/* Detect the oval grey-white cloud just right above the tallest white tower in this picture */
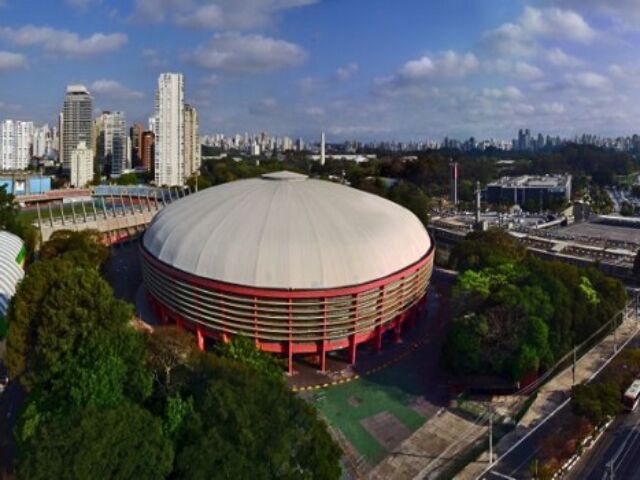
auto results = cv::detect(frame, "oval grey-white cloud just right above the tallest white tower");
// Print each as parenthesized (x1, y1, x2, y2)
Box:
(183, 33, 307, 73)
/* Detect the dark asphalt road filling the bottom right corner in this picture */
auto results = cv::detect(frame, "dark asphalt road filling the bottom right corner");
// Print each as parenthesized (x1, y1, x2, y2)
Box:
(567, 409, 640, 480)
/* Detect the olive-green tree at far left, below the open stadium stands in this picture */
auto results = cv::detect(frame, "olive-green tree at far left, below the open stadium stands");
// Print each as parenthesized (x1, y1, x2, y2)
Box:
(6, 259, 133, 387)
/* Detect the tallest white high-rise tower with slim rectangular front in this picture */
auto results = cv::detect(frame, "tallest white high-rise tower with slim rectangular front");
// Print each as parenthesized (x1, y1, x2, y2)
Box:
(154, 73, 185, 186)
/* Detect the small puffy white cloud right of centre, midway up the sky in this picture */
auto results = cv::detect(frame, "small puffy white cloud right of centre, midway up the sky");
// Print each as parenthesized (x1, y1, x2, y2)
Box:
(398, 50, 480, 81)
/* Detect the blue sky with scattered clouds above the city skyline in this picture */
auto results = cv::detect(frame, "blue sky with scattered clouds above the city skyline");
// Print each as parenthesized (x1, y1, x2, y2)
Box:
(0, 0, 640, 140)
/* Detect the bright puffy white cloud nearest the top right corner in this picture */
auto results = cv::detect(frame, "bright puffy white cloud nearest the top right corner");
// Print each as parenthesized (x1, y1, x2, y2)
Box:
(485, 7, 596, 55)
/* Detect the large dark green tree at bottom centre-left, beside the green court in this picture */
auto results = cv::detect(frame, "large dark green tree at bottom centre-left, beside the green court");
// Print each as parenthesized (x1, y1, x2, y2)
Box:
(174, 355, 340, 480)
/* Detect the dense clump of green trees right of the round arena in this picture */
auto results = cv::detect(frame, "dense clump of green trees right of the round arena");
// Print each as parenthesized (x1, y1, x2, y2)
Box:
(444, 230, 626, 380)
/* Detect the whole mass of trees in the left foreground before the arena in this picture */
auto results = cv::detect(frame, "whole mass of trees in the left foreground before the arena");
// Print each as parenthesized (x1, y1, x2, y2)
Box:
(6, 232, 341, 480)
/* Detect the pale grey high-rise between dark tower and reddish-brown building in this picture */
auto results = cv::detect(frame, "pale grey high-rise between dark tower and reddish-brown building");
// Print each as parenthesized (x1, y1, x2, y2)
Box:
(96, 112, 127, 175)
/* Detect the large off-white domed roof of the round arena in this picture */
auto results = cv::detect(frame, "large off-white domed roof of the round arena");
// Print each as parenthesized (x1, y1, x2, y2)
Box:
(143, 172, 431, 289)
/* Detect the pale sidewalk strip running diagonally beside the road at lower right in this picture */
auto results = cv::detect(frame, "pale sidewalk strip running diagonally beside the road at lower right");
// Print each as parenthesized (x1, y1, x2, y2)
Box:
(456, 317, 640, 480)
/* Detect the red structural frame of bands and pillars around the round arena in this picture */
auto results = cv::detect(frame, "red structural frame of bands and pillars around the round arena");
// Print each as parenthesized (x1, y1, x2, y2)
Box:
(140, 241, 435, 373)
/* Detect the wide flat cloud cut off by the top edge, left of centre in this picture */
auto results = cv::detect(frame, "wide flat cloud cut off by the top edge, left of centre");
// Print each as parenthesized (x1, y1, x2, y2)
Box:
(132, 0, 318, 30)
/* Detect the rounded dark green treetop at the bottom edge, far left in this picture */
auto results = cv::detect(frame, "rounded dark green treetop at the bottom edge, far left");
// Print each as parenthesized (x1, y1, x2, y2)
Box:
(18, 404, 173, 480)
